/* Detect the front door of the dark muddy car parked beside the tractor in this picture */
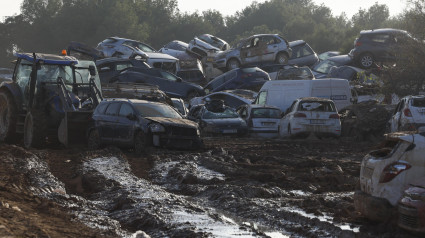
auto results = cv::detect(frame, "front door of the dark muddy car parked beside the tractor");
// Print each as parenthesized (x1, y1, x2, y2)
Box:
(114, 102, 138, 145)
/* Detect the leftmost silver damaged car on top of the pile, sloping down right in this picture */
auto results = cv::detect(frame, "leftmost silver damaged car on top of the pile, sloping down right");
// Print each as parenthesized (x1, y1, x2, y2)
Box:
(96, 37, 180, 73)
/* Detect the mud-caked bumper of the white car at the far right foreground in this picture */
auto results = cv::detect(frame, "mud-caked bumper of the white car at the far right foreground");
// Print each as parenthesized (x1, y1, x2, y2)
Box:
(354, 190, 397, 221)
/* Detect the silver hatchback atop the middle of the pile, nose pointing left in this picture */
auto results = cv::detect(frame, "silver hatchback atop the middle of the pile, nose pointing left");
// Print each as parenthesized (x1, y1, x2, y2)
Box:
(213, 34, 292, 70)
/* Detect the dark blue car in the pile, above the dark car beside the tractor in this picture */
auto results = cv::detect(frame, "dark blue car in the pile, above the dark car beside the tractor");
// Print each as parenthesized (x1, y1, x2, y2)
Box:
(109, 67, 205, 99)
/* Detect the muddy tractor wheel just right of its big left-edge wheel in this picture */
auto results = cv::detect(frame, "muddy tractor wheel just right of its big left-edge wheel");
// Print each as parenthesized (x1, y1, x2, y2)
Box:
(24, 110, 47, 148)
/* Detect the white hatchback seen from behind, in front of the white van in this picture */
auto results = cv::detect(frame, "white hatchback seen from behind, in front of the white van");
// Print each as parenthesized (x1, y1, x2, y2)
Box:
(279, 97, 341, 138)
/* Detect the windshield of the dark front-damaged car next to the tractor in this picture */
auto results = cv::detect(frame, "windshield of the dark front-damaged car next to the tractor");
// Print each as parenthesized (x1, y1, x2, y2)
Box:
(134, 103, 182, 118)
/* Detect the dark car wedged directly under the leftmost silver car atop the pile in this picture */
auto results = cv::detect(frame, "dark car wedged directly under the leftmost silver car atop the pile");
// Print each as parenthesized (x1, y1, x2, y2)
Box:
(96, 57, 150, 84)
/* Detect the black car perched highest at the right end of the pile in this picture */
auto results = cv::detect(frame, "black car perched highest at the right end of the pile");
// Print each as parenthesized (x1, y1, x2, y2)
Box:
(349, 29, 415, 68)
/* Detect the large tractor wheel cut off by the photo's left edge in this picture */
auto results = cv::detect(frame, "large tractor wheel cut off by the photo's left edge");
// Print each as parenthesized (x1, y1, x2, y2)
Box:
(0, 90, 18, 143)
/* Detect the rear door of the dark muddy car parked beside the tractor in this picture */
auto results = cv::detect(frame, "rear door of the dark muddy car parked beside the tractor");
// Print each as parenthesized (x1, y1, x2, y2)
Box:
(97, 102, 120, 144)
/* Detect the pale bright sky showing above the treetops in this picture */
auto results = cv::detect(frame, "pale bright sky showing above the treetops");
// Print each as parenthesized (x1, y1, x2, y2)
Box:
(0, 0, 407, 21)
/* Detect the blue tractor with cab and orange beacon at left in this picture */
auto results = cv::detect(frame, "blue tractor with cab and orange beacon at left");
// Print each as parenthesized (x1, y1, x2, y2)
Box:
(0, 53, 103, 148)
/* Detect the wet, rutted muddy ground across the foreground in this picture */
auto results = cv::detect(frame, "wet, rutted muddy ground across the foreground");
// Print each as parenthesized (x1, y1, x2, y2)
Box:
(0, 138, 420, 237)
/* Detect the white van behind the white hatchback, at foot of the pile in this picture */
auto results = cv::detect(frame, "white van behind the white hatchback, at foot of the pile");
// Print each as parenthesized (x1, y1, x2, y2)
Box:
(254, 79, 354, 112)
